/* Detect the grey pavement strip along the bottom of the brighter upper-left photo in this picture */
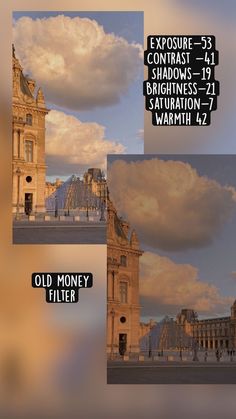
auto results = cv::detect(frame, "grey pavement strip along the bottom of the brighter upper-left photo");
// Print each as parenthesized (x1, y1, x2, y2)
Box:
(13, 221, 106, 244)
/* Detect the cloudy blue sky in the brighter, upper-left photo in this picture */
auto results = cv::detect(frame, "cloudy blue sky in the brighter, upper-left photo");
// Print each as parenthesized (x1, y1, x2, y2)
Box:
(13, 12, 144, 180)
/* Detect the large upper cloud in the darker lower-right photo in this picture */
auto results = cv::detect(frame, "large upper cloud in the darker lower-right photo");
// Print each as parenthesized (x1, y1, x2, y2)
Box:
(108, 158, 235, 250)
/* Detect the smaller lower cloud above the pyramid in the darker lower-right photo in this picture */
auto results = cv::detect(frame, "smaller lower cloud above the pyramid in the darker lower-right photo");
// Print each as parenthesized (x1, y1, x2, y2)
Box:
(140, 252, 234, 316)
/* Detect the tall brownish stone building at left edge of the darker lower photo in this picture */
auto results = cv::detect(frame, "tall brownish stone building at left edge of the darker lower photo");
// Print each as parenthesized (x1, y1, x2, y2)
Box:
(107, 199, 143, 358)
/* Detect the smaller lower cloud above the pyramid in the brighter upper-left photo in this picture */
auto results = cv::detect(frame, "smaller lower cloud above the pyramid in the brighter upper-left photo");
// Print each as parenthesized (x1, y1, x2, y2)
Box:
(46, 110, 125, 175)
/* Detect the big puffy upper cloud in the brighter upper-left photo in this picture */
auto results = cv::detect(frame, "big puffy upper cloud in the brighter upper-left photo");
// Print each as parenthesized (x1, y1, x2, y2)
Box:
(13, 15, 142, 110)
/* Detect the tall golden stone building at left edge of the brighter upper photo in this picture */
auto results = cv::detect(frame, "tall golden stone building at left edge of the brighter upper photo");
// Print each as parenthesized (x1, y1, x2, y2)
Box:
(12, 47, 49, 216)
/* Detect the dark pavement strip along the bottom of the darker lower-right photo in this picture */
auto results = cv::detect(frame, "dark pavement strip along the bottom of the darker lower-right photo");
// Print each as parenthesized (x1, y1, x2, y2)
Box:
(107, 362, 236, 384)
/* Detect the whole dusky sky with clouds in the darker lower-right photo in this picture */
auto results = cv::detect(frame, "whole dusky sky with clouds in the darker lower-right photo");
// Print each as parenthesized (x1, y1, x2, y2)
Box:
(108, 155, 236, 321)
